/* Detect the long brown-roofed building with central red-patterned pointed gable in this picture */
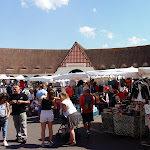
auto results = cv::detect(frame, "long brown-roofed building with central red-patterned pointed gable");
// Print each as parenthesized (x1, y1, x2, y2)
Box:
(0, 42, 150, 77)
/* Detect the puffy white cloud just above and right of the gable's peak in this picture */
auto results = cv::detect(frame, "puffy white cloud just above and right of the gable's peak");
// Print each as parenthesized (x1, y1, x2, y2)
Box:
(79, 26, 95, 38)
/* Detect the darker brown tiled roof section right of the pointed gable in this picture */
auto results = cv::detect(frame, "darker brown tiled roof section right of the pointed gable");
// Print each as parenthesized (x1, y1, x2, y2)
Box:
(84, 45, 150, 69)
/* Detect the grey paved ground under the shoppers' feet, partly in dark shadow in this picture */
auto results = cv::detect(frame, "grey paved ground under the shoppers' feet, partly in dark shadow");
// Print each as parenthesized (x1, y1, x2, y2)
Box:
(0, 111, 150, 150)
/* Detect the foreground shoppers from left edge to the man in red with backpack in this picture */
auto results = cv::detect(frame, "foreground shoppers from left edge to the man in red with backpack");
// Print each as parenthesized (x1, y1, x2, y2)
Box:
(0, 79, 95, 147)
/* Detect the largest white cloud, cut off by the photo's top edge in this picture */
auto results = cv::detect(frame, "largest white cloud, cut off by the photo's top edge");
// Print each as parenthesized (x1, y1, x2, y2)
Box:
(21, 0, 69, 11)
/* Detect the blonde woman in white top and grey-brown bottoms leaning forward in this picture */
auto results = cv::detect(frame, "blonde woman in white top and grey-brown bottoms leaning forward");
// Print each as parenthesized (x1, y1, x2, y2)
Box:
(60, 92, 78, 145)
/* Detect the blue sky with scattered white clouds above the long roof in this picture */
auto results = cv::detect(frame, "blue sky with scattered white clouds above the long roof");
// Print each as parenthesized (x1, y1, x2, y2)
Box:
(0, 0, 150, 49)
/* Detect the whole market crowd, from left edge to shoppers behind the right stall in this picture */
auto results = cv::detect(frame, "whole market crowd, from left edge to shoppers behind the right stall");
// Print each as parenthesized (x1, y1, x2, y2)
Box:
(0, 80, 143, 147)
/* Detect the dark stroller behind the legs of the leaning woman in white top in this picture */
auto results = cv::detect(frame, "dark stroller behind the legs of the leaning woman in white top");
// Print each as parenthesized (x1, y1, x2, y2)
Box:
(56, 115, 80, 142)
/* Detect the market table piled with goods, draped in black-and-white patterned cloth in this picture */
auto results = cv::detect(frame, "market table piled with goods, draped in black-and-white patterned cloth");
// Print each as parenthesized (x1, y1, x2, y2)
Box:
(101, 96, 149, 138)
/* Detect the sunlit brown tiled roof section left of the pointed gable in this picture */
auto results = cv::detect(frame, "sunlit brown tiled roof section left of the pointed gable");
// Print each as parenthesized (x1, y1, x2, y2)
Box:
(0, 48, 68, 74)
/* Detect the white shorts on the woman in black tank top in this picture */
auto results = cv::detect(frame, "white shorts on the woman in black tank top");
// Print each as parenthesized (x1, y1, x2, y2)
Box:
(40, 109, 54, 122)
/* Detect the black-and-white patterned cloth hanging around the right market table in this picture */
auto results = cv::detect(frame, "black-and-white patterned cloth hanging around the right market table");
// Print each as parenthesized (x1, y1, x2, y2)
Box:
(101, 110, 149, 138)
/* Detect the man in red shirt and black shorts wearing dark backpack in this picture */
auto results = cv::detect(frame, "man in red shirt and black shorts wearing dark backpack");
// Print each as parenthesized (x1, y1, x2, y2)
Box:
(79, 85, 95, 136)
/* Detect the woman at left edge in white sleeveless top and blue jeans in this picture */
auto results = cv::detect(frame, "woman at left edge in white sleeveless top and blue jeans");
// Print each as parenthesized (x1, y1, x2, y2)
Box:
(0, 93, 10, 146)
